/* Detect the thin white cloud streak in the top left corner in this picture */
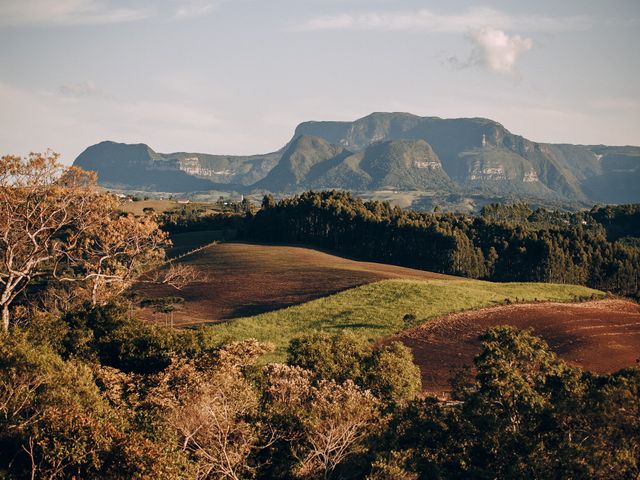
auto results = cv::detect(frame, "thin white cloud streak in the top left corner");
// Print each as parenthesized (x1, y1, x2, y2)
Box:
(0, 0, 151, 26)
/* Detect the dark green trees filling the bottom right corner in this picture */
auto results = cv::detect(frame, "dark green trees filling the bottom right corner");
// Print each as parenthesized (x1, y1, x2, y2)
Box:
(381, 327, 640, 479)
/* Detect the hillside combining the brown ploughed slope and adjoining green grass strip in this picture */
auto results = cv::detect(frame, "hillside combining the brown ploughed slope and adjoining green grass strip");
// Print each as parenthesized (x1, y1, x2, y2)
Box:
(136, 243, 601, 366)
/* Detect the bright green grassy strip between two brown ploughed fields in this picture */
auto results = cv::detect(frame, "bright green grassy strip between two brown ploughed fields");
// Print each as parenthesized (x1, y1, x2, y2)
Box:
(199, 280, 604, 362)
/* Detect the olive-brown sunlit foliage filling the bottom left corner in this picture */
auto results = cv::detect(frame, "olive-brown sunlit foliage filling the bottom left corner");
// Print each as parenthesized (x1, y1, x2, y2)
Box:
(0, 331, 190, 479)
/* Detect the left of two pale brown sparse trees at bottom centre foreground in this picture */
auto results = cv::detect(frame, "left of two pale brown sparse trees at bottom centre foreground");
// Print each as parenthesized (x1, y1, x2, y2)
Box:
(153, 340, 272, 480)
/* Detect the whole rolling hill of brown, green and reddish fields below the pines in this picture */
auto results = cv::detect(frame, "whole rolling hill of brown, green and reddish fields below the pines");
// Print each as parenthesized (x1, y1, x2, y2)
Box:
(130, 243, 640, 376)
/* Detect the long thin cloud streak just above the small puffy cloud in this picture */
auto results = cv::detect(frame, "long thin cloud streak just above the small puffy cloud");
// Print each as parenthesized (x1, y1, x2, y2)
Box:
(294, 7, 592, 33)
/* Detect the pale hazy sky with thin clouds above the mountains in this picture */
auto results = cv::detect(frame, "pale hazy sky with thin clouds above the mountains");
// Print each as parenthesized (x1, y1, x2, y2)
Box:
(0, 0, 640, 163)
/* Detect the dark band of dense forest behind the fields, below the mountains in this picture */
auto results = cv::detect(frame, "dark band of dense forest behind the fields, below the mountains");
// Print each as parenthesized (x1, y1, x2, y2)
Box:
(243, 191, 640, 298)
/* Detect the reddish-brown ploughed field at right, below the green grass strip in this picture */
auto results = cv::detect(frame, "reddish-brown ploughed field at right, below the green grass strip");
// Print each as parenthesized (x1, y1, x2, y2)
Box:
(396, 299, 640, 393)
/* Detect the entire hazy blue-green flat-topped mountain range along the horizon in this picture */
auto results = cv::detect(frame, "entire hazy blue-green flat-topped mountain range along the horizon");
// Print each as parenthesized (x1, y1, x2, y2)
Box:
(74, 113, 640, 204)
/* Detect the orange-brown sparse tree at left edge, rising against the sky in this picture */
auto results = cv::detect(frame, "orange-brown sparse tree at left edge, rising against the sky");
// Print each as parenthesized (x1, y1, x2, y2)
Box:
(0, 151, 97, 331)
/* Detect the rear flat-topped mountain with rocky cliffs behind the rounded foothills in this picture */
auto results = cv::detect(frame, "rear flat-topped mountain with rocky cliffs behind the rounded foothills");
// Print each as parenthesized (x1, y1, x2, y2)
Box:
(296, 113, 640, 202)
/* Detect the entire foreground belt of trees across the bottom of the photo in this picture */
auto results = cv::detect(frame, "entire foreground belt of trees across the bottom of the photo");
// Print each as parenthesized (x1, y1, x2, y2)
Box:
(0, 302, 640, 480)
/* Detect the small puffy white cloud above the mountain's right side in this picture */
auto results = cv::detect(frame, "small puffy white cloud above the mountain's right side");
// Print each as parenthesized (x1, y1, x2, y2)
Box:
(467, 27, 533, 75)
